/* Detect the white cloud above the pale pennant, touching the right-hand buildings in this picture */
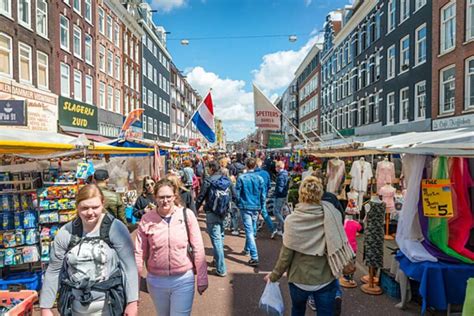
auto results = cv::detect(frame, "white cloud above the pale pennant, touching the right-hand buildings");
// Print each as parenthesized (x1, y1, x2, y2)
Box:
(252, 34, 322, 95)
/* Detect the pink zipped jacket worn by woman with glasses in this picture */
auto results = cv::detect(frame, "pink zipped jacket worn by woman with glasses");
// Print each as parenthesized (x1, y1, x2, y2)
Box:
(135, 208, 208, 286)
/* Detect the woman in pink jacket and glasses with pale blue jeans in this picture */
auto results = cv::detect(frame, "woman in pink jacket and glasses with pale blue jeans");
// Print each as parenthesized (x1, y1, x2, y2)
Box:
(135, 179, 208, 316)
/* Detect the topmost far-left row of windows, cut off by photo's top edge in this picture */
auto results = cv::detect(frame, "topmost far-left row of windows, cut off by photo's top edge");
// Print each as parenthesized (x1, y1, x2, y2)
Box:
(0, 0, 48, 38)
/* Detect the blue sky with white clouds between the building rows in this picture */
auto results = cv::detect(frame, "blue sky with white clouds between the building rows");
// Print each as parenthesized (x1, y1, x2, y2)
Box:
(148, 0, 349, 140)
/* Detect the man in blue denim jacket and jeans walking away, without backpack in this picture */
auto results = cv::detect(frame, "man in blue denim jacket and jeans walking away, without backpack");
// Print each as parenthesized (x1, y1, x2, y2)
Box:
(235, 158, 266, 267)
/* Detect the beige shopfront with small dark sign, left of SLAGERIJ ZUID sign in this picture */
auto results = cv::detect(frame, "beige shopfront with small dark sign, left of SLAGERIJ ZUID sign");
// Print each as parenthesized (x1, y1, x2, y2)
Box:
(0, 80, 58, 132)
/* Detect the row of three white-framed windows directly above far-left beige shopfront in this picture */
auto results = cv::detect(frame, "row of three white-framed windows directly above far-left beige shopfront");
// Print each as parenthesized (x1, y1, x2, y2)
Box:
(0, 33, 49, 90)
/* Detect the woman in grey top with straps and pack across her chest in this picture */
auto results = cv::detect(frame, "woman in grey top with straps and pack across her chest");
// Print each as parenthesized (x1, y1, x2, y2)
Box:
(40, 184, 138, 316)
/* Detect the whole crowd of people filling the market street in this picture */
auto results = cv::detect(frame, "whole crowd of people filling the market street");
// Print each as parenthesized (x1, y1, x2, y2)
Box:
(40, 154, 358, 316)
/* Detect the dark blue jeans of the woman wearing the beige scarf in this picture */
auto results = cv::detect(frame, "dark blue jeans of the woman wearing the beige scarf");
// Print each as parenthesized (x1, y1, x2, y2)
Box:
(289, 280, 337, 316)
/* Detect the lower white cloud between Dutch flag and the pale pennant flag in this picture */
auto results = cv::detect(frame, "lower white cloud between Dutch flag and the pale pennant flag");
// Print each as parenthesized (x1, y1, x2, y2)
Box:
(186, 67, 255, 140)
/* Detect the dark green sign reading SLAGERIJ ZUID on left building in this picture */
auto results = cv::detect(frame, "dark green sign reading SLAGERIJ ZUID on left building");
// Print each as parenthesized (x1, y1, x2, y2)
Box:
(59, 97, 98, 131)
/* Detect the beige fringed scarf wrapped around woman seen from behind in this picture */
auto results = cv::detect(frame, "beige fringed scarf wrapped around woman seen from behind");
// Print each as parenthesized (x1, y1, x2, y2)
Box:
(283, 201, 355, 277)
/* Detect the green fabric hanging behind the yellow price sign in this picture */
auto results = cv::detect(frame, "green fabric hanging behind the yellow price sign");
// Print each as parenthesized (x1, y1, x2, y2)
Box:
(428, 157, 474, 263)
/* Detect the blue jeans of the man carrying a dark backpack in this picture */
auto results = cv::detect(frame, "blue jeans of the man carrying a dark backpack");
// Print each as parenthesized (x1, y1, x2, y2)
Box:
(206, 213, 226, 274)
